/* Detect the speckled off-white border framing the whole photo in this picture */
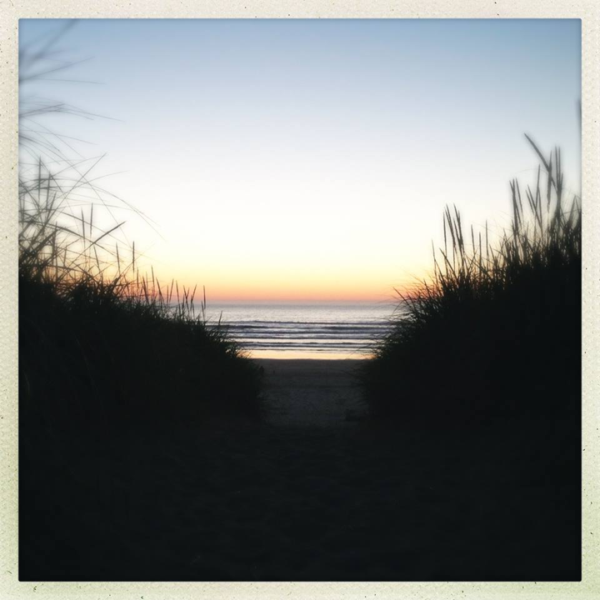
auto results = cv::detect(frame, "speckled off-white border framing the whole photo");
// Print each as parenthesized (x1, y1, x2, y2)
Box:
(0, 0, 600, 600)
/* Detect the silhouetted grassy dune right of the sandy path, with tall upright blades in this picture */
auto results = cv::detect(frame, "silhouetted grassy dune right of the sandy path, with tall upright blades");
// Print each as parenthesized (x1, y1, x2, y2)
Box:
(362, 138, 581, 423)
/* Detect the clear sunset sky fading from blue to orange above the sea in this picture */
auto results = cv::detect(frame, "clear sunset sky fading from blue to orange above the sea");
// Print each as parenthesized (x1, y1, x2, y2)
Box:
(19, 19, 581, 301)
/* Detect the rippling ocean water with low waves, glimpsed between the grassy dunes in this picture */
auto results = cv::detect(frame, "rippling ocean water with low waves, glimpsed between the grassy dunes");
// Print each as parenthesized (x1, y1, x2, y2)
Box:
(206, 302, 408, 359)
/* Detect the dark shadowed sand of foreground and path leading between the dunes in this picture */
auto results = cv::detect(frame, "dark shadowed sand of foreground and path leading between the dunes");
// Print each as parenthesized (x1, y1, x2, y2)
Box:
(21, 360, 580, 581)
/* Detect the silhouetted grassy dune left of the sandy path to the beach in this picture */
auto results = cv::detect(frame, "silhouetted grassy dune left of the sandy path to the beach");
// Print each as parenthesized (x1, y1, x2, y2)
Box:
(19, 161, 260, 440)
